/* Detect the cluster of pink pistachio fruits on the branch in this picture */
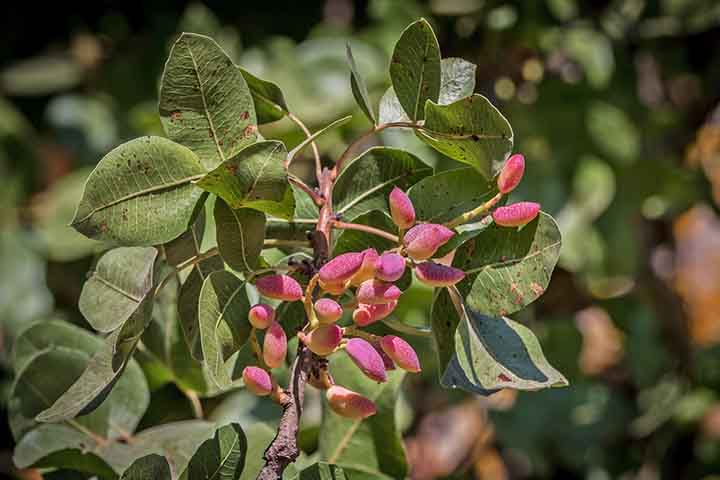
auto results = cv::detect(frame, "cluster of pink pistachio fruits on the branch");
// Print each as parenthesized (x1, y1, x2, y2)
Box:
(243, 154, 540, 419)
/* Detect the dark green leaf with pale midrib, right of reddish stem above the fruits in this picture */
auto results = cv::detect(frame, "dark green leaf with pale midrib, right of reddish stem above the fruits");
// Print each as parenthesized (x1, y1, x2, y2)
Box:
(333, 147, 433, 221)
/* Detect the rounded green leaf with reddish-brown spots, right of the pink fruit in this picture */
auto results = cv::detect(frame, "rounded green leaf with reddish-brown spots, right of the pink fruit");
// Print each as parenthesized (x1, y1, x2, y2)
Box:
(453, 212, 561, 317)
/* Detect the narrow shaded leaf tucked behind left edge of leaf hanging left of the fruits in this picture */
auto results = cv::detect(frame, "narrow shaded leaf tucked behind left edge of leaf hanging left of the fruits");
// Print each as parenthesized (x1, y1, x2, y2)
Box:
(178, 256, 224, 360)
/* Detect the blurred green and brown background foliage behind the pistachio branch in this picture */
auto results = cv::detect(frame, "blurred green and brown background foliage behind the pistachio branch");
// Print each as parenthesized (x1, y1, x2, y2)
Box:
(0, 0, 720, 480)
